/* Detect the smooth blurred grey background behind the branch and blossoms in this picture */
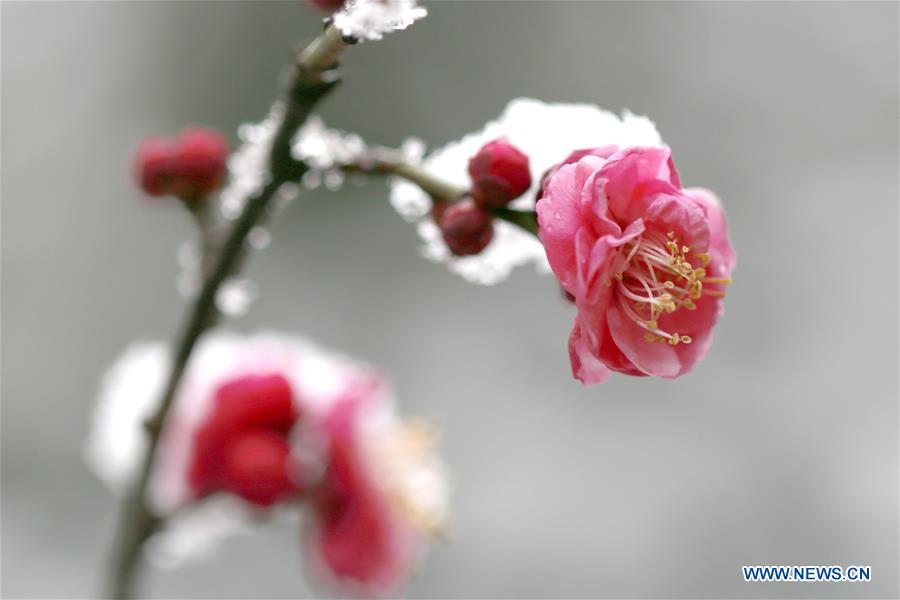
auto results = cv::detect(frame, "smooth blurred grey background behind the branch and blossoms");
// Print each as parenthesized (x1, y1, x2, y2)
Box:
(0, 0, 900, 598)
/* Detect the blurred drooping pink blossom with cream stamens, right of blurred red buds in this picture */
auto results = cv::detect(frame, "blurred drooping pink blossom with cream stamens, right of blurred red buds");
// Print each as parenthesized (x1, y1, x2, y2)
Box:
(307, 380, 444, 597)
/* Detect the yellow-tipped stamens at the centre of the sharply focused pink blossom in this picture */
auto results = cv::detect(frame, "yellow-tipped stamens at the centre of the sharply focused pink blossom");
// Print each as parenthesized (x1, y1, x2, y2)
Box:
(615, 231, 731, 346)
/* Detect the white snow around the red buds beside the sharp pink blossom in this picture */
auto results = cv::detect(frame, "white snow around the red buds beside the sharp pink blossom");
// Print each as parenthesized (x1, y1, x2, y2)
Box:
(391, 98, 662, 285)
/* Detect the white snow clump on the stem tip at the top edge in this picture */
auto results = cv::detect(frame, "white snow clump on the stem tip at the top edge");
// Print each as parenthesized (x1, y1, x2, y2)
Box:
(334, 0, 428, 40)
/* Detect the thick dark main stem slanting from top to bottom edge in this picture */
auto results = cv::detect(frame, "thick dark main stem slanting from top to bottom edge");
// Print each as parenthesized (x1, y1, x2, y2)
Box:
(109, 25, 346, 599)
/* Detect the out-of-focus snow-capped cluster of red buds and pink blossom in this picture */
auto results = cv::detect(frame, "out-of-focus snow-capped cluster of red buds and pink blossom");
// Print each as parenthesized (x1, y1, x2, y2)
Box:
(88, 332, 447, 597)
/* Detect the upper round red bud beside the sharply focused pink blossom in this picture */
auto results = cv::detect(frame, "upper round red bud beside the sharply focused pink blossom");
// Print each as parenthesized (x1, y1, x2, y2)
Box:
(469, 139, 531, 209)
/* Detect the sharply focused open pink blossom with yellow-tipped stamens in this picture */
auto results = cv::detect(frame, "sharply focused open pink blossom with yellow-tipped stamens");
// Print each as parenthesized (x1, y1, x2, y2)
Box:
(537, 147, 735, 385)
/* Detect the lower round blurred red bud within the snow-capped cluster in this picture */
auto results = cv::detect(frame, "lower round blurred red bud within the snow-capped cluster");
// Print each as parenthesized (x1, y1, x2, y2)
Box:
(222, 431, 294, 506)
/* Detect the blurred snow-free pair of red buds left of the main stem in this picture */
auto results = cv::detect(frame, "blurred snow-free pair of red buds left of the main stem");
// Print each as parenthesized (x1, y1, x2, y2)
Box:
(135, 127, 228, 201)
